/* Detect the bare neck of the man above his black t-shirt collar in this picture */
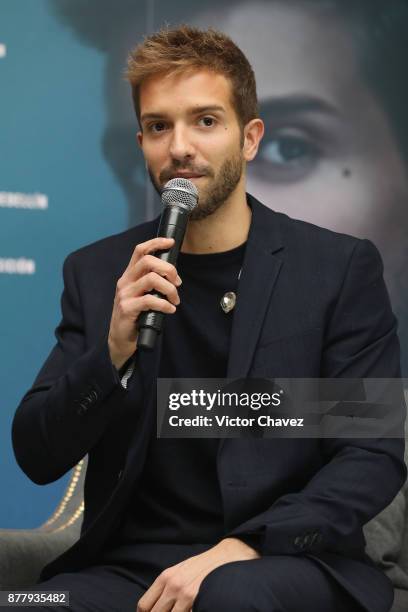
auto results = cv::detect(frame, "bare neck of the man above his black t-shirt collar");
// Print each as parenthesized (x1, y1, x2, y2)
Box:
(181, 178, 252, 254)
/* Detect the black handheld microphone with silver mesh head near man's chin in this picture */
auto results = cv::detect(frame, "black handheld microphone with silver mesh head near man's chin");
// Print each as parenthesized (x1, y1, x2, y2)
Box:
(137, 178, 198, 350)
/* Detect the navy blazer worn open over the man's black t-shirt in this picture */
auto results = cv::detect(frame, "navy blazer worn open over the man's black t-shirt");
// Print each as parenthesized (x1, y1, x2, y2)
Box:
(12, 196, 406, 612)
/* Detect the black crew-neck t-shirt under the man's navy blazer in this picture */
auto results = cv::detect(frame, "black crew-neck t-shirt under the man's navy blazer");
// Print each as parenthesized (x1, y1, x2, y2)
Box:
(115, 243, 262, 544)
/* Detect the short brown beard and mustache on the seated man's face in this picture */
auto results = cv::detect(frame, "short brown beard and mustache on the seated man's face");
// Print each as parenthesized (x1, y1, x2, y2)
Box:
(147, 149, 243, 221)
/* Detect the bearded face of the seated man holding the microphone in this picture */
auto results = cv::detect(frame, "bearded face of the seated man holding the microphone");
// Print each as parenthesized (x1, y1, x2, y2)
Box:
(138, 70, 244, 220)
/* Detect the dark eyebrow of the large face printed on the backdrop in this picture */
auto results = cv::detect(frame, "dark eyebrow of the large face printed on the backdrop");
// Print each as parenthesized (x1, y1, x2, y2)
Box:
(259, 95, 340, 118)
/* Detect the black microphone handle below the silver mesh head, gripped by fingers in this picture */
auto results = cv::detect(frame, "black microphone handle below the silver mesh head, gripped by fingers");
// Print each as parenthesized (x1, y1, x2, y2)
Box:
(137, 204, 190, 350)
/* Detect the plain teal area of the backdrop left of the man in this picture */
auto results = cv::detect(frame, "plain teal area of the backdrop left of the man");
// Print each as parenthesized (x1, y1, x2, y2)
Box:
(0, 0, 146, 528)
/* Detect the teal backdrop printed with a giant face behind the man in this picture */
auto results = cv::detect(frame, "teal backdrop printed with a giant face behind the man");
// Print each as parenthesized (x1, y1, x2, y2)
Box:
(0, 0, 408, 528)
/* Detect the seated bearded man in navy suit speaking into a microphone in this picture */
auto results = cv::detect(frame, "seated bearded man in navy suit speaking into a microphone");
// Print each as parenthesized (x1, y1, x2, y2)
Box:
(13, 26, 406, 612)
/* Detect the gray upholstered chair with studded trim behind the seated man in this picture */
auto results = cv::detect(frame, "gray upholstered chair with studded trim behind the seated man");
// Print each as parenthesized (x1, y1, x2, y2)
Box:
(0, 393, 408, 612)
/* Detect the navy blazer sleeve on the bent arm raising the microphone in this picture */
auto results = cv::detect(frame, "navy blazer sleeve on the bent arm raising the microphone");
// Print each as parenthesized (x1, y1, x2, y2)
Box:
(12, 254, 140, 484)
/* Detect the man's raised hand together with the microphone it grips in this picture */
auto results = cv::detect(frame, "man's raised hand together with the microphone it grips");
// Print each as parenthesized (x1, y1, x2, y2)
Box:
(108, 178, 198, 370)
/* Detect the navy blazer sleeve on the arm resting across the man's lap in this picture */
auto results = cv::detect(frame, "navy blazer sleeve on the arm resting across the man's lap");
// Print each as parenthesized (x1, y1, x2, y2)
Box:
(228, 240, 406, 557)
